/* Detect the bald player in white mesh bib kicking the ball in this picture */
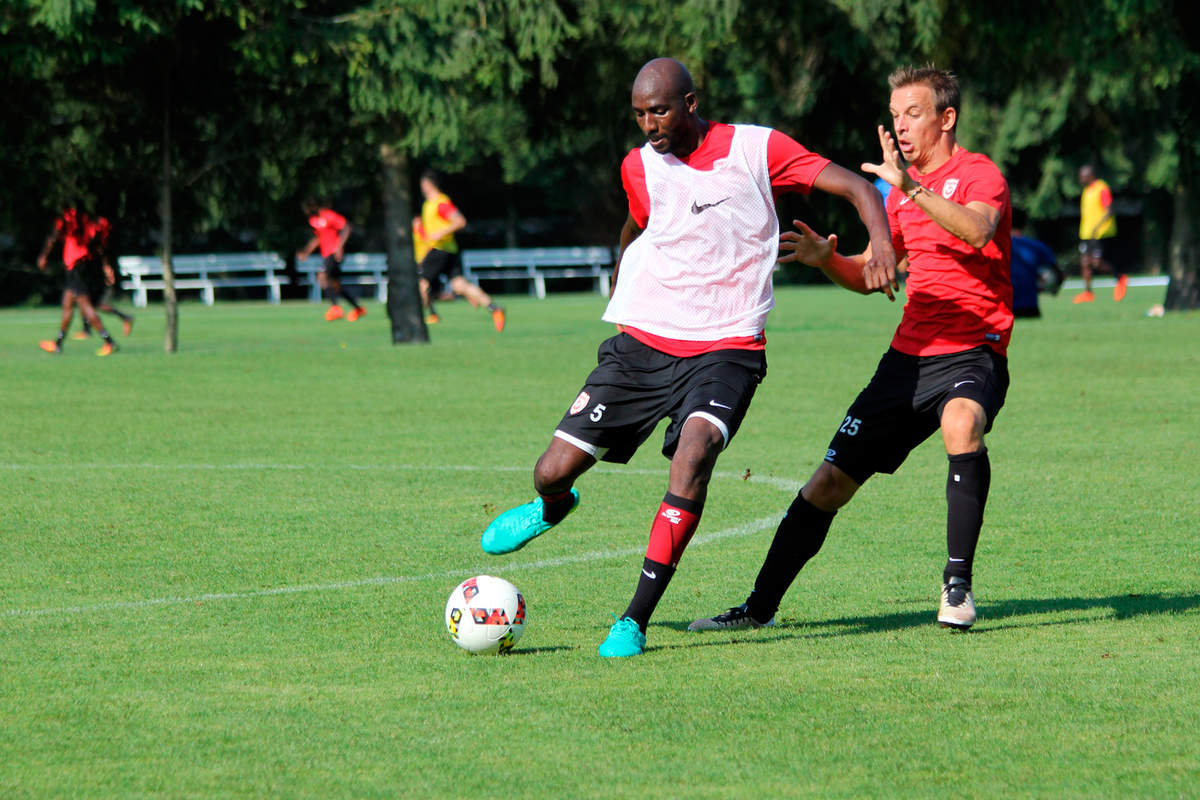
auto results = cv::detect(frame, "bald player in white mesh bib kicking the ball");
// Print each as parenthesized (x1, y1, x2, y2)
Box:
(481, 59, 895, 657)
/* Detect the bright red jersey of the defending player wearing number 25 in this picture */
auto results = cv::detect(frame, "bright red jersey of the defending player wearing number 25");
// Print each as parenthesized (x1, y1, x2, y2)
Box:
(887, 148, 1013, 356)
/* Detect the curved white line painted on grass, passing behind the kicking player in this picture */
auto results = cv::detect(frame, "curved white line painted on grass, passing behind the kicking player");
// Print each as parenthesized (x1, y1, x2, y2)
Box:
(0, 464, 800, 618)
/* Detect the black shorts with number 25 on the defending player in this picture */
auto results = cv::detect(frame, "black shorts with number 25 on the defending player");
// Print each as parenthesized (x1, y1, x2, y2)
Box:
(826, 347, 1008, 485)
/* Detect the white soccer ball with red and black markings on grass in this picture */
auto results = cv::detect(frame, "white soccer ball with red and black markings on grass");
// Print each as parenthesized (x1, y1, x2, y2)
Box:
(446, 575, 524, 654)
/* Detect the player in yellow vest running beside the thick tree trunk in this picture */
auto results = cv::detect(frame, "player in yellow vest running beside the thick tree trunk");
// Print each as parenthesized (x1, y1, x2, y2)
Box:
(413, 170, 504, 331)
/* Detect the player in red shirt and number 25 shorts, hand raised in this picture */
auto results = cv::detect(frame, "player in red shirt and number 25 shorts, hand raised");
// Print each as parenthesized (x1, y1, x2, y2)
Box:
(689, 67, 1013, 631)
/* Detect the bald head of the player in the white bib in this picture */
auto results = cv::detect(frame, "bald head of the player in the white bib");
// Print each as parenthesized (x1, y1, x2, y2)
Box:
(632, 59, 708, 158)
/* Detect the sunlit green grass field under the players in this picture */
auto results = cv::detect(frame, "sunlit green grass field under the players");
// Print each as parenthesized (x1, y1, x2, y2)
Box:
(0, 288, 1200, 798)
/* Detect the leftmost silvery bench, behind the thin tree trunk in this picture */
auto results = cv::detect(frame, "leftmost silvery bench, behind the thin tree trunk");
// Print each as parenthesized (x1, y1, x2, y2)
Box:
(116, 253, 288, 308)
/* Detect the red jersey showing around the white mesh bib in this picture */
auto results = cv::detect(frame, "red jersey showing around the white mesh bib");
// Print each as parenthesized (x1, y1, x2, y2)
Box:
(618, 122, 829, 356)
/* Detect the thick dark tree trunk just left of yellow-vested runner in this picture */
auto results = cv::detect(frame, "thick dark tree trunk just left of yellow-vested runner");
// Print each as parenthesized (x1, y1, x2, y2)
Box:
(379, 144, 430, 344)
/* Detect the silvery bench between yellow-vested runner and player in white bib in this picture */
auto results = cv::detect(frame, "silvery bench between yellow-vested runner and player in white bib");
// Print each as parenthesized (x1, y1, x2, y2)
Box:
(462, 247, 612, 299)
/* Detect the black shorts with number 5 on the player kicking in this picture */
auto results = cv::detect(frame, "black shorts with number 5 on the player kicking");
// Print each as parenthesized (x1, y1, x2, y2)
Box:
(554, 333, 767, 464)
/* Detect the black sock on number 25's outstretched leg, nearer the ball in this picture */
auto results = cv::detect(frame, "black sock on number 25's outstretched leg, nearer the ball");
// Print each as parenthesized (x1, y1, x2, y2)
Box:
(746, 494, 838, 622)
